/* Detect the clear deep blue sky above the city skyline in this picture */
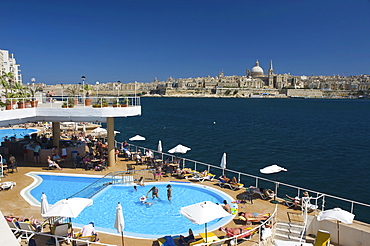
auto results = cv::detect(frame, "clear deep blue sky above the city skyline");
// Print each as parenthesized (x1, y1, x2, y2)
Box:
(0, 0, 370, 84)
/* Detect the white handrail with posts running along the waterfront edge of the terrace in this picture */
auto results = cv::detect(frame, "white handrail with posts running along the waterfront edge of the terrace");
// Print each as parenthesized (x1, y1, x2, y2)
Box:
(117, 142, 370, 221)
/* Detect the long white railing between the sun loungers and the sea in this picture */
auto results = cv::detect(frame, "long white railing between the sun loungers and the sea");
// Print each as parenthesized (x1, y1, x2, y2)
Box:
(115, 142, 370, 222)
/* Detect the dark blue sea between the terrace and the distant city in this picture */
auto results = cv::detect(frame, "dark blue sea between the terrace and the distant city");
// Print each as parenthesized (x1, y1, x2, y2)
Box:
(115, 97, 370, 221)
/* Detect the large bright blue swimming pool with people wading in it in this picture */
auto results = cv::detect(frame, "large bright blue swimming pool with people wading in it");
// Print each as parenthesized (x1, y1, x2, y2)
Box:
(22, 172, 237, 239)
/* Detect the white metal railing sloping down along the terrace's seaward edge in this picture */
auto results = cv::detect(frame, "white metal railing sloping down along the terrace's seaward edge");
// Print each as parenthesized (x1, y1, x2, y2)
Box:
(119, 142, 370, 223)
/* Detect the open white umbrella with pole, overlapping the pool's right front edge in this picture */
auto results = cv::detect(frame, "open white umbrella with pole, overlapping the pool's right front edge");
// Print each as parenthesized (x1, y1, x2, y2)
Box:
(180, 201, 230, 242)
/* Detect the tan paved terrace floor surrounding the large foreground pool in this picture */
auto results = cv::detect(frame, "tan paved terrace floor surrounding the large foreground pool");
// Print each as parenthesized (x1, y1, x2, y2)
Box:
(0, 157, 364, 246)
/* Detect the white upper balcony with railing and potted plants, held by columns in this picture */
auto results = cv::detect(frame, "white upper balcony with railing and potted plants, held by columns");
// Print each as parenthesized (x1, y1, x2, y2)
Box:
(0, 96, 141, 126)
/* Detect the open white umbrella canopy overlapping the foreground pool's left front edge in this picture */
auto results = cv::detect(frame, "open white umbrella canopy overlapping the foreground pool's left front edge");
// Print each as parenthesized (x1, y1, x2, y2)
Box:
(41, 197, 93, 218)
